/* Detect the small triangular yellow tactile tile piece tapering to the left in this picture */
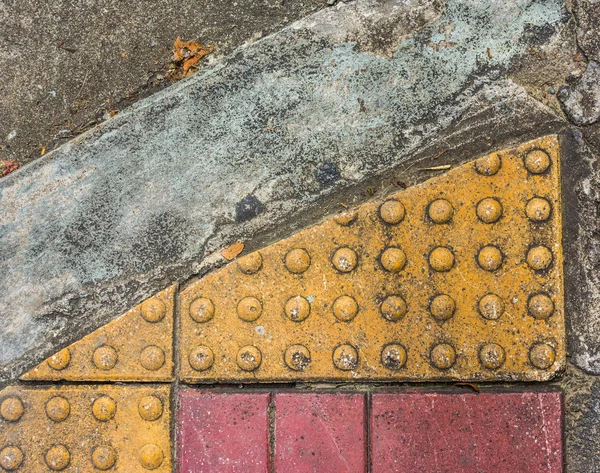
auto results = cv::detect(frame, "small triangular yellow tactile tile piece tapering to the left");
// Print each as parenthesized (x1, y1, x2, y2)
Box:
(21, 286, 176, 382)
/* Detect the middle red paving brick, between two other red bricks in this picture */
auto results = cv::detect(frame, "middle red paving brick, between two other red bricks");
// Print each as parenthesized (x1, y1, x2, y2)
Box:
(275, 393, 366, 473)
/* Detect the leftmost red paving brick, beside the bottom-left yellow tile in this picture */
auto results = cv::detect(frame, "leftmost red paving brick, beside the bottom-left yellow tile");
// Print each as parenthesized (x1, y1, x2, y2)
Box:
(177, 390, 270, 473)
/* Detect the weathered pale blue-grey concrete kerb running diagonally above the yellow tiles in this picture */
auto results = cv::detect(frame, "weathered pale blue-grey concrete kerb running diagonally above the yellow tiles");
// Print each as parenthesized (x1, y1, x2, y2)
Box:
(0, 0, 569, 379)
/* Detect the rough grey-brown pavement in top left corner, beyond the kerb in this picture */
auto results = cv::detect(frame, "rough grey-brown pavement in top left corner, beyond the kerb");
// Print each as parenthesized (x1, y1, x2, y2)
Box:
(0, 0, 324, 168)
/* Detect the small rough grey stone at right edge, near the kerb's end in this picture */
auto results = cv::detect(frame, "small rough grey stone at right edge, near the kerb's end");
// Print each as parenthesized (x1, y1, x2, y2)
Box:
(558, 61, 600, 125)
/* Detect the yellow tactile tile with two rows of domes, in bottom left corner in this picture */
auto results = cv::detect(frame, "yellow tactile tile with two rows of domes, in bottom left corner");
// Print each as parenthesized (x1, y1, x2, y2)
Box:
(0, 385, 171, 473)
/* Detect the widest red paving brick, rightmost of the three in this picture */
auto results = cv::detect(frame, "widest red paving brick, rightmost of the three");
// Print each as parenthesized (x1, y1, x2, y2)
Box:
(371, 392, 563, 473)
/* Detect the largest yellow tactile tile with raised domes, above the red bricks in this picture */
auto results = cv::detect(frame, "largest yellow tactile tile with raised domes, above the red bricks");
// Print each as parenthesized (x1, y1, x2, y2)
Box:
(179, 136, 565, 382)
